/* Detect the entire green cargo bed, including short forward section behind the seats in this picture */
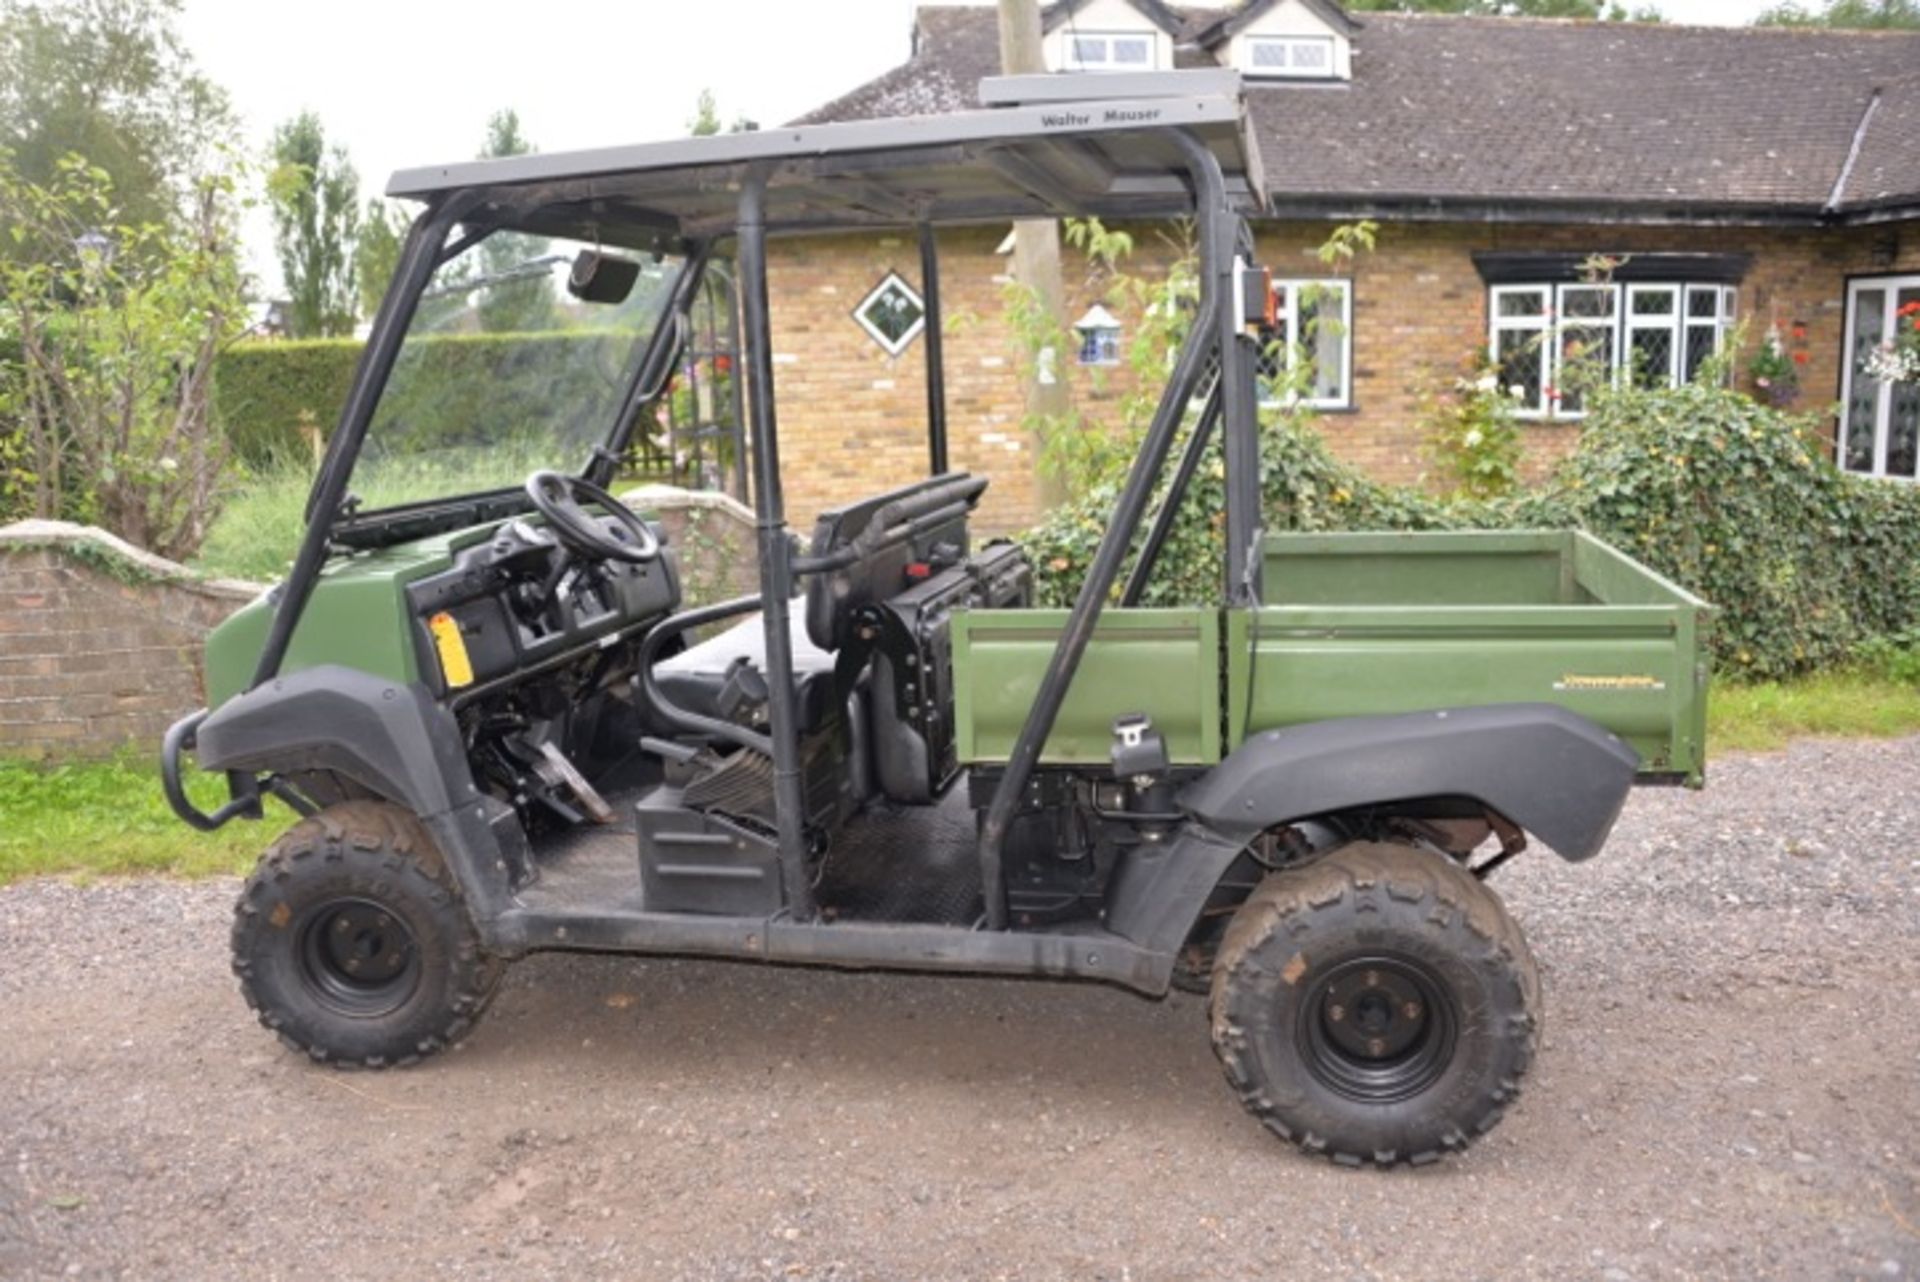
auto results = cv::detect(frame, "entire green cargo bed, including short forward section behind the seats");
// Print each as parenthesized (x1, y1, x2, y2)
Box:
(954, 530, 1709, 787)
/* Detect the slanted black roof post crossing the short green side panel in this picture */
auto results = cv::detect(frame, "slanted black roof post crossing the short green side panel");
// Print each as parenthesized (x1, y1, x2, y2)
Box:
(979, 129, 1236, 931)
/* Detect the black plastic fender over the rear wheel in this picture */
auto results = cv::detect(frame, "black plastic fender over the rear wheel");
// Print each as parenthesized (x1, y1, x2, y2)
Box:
(1108, 702, 1640, 965)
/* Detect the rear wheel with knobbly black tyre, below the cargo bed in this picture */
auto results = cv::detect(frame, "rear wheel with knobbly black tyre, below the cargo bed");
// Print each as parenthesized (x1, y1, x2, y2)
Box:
(1212, 844, 1540, 1165)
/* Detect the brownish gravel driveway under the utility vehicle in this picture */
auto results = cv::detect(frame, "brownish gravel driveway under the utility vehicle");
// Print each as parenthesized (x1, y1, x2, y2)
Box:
(0, 739, 1920, 1282)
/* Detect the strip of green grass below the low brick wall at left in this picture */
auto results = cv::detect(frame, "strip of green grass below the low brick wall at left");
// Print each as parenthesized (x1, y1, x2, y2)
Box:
(0, 752, 294, 885)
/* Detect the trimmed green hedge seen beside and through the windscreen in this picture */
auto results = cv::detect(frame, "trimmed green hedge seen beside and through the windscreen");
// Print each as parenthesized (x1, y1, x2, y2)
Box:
(213, 330, 634, 466)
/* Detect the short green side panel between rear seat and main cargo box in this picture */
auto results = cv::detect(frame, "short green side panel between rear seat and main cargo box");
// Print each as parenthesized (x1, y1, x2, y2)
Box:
(952, 608, 1221, 766)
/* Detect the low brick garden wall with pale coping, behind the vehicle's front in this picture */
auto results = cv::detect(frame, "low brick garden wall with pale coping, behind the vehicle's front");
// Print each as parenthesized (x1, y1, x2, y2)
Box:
(0, 486, 756, 758)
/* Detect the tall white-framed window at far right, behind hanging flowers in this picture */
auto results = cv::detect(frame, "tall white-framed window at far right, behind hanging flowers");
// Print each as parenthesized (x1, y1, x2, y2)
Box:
(1839, 274, 1920, 480)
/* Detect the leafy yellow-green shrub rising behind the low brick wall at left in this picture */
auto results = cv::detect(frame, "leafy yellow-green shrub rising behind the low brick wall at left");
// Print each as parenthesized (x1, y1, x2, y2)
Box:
(0, 150, 246, 558)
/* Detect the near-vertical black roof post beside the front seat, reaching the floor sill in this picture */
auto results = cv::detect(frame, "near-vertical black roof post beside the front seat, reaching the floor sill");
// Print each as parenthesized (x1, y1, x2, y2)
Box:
(737, 167, 814, 921)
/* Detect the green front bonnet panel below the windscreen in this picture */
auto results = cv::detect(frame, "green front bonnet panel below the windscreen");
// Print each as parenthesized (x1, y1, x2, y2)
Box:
(196, 526, 493, 708)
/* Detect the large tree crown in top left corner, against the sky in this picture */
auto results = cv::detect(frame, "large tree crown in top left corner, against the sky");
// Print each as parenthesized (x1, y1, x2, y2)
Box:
(0, 0, 234, 255)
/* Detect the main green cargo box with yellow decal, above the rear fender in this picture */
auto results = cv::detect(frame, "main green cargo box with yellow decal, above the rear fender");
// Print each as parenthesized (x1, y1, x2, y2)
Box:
(1227, 530, 1707, 785)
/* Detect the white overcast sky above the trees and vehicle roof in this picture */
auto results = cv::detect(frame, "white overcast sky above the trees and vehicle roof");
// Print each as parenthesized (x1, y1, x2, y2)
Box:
(182, 0, 1766, 286)
